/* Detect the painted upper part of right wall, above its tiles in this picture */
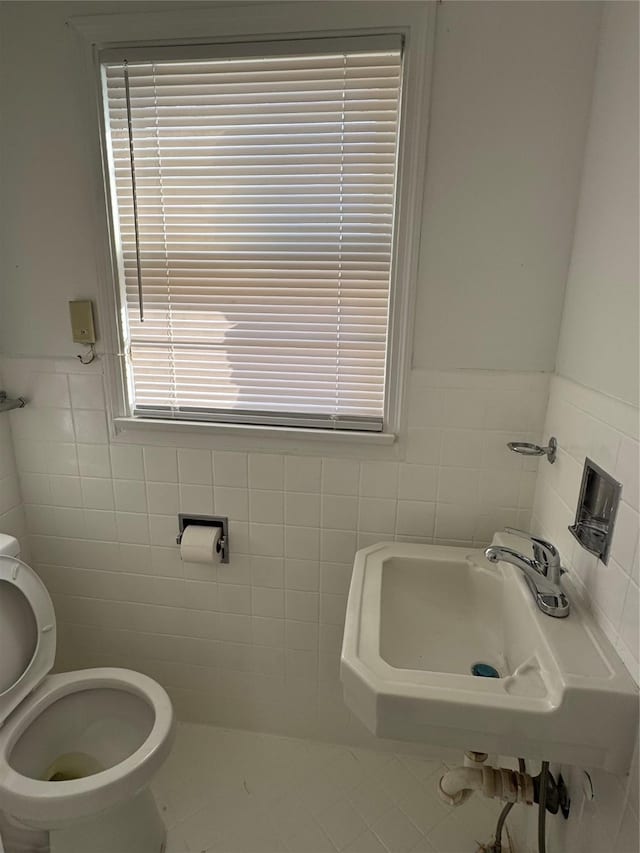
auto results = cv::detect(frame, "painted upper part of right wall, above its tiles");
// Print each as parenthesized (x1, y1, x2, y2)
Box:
(558, 3, 640, 406)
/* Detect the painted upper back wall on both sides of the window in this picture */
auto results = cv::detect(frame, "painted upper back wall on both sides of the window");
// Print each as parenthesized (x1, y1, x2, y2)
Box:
(0, 0, 600, 370)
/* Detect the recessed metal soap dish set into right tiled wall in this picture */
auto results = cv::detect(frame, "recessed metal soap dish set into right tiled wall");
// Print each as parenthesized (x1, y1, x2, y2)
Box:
(569, 458, 622, 565)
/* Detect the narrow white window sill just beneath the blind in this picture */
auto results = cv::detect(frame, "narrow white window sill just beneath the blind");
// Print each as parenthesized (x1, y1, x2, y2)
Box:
(113, 417, 396, 446)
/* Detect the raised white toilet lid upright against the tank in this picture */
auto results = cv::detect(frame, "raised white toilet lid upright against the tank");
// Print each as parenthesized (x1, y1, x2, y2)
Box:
(0, 555, 56, 725)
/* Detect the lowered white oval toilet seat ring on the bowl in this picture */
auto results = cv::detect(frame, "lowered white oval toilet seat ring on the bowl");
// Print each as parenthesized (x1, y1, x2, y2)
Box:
(0, 668, 174, 828)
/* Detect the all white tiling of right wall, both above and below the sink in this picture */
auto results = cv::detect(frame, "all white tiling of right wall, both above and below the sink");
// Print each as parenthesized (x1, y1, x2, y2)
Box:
(522, 376, 640, 853)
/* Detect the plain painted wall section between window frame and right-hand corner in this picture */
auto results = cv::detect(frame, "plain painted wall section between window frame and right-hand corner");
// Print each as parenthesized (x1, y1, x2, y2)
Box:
(414, 2, 600, 370)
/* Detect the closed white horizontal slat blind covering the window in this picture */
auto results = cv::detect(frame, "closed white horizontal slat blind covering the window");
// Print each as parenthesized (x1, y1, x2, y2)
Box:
(102, 40, 401, 430)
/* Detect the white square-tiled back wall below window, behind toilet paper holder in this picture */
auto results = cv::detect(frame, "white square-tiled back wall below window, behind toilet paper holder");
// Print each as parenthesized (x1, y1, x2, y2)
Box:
(3, 358, 548, 740)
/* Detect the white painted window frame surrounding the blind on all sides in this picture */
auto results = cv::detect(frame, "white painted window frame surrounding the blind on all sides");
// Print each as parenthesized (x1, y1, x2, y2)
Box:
(68, 0, 435, 444)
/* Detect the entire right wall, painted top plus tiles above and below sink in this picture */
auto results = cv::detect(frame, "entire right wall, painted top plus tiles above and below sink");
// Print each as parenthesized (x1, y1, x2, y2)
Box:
(529, 3, 640, 853)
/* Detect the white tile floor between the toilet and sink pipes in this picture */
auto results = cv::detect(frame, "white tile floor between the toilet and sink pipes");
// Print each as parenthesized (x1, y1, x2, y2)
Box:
(154, 724, 508, 853)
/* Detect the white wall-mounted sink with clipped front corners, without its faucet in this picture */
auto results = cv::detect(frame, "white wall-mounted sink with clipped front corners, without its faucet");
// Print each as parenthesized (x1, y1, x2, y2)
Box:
(341, 533, 638, 773)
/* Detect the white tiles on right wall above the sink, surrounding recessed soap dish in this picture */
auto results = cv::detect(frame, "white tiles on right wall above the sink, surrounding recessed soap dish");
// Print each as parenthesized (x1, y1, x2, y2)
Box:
(532, 376, 640, 682)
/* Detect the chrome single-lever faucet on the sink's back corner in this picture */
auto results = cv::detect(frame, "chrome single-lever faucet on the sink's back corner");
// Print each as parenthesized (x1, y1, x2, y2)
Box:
(484, 527, 569, 618)
